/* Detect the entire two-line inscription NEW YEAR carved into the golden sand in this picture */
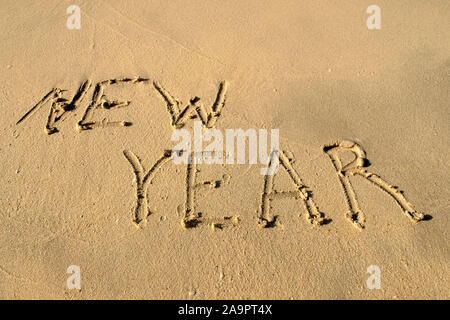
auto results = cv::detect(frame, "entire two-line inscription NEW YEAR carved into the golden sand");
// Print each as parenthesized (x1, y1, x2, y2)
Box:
(17, 77, 430, 230)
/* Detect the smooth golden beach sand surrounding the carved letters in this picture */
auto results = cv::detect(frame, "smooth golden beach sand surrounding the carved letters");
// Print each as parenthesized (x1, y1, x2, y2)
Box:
(0, 0, 450, 299)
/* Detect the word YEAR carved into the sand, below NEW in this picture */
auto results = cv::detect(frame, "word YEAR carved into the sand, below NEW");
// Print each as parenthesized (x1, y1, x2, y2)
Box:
(124, 141, 429, 230)
